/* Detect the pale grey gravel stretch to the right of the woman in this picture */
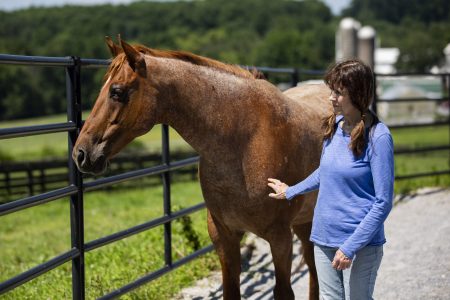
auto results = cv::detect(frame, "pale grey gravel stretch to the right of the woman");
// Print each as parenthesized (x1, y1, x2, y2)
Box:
(374, 189, 450, 300)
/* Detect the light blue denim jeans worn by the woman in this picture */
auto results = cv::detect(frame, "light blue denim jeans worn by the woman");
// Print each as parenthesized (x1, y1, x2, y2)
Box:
(314, 244, 383, 300)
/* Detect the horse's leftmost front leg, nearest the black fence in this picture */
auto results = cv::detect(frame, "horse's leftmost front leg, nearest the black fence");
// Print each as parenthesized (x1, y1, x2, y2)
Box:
(208, 210, 243, 300)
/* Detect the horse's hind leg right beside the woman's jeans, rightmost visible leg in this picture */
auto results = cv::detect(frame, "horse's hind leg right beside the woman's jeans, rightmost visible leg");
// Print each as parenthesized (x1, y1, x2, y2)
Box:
(293, 222, 319, 300)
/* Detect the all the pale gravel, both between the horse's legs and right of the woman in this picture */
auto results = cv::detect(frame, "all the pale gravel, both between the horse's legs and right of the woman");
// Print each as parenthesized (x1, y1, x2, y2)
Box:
(175, 189, 450, 300)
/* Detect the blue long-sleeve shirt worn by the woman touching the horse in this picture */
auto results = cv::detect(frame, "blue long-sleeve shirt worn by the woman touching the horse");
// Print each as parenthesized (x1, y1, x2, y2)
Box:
(286, 116, 394, 258)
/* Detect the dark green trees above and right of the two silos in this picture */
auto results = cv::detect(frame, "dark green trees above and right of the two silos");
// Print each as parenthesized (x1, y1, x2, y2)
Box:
(344, 0, 450, 72)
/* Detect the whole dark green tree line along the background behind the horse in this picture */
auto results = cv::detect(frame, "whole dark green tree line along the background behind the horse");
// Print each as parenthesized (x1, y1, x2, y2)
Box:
(0, 0, 450, 120)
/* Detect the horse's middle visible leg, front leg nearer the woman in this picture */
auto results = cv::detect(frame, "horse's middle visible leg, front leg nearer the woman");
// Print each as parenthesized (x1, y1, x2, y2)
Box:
(267, 227, 294, 300)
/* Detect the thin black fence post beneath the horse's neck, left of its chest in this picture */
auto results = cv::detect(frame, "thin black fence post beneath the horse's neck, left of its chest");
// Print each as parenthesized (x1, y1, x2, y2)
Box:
(161, 124, 172, 266)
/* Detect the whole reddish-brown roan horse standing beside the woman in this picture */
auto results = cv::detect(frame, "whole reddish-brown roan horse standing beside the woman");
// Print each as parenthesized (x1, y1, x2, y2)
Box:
(72, 37, 331, 300)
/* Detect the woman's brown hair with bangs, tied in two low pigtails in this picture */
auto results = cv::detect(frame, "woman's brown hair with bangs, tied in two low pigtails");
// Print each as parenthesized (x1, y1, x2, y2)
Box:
(323, 59, 376, 156)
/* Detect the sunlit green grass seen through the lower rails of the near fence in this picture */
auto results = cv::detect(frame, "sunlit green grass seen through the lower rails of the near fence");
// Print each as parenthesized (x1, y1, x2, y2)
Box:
(0, 182, 219, 299)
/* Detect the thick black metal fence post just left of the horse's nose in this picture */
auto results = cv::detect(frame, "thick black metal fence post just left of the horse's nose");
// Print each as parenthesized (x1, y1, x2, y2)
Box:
(66, 57, 85, 300)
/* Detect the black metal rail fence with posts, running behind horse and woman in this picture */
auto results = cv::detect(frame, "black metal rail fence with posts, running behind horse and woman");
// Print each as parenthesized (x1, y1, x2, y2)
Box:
(0, 55, 450, 299)
